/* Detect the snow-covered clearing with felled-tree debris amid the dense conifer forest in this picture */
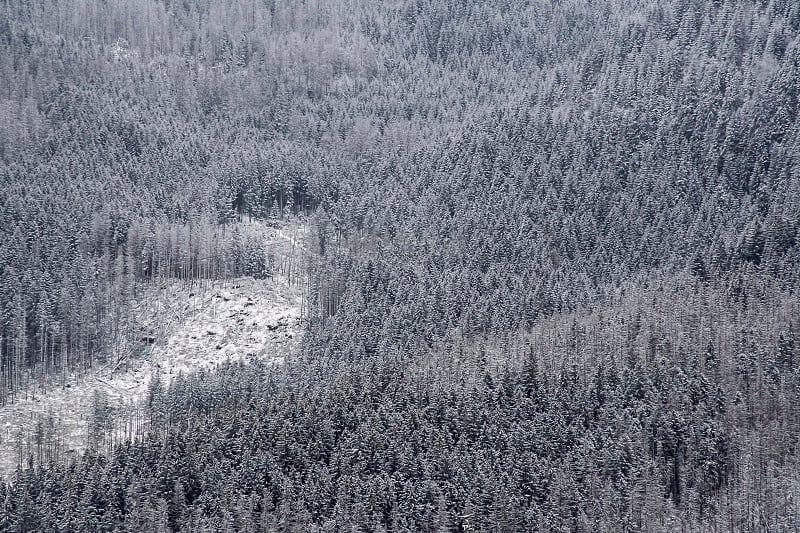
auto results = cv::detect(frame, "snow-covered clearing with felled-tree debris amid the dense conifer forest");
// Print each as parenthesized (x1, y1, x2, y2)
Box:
(0, 219, 307, 479)
